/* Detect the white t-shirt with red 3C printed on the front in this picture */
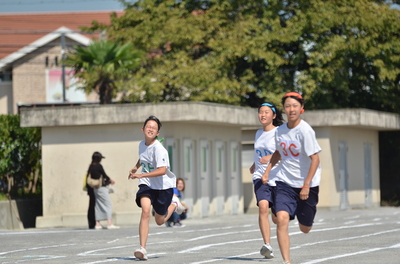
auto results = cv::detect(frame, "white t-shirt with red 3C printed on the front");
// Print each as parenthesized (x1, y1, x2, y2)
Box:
(275, 120, 321, 188)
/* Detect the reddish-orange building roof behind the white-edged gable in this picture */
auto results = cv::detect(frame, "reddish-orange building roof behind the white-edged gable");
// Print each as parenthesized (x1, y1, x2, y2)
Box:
(0, 11, 123, 66)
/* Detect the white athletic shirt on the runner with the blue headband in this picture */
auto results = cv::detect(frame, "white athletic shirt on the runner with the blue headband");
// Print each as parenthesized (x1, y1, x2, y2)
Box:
(253, 128, 278, 186)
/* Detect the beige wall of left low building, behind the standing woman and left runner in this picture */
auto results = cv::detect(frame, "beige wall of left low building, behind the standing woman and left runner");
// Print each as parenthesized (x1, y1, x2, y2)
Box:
(37, 122, 243, 227)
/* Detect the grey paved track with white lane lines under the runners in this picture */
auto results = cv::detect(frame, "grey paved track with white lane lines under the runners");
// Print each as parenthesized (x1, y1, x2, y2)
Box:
(0, 207, 400, 264)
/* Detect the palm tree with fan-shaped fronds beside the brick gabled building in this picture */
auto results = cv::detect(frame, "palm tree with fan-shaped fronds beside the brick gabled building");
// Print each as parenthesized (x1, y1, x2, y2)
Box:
(64, 40, 142, 104)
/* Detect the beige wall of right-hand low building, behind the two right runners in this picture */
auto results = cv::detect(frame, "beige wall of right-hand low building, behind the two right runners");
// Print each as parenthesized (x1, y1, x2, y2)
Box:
(242, 127, 380, 212)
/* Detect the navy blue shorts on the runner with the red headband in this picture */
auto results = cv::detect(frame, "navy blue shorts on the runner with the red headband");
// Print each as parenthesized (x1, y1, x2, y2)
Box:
(272, 181, 319, 226)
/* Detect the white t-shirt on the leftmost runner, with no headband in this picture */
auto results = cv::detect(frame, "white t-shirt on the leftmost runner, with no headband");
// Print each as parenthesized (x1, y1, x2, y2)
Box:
(138, 140, 176, 190)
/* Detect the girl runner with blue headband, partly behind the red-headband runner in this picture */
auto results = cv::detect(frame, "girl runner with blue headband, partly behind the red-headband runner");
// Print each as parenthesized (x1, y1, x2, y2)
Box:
(250, 103, 283, 259)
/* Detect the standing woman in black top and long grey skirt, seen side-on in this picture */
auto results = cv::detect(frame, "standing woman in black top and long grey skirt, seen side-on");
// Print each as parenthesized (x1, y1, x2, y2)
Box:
(88, 151, 119, 229)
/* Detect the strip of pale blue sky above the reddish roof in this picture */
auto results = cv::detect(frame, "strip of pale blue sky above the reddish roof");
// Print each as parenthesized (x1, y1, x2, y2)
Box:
(0, 0, 123, 14)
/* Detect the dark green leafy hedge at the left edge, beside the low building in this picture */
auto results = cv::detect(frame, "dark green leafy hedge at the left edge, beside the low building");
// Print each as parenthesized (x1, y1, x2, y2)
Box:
(0, 115, 41, 197)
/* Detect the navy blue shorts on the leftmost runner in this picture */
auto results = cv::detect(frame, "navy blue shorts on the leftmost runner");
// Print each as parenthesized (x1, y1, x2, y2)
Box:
(136, 184, 174, 215)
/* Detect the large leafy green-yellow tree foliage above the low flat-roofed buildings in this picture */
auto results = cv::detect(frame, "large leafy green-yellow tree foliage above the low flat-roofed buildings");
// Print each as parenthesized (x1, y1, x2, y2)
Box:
(91, 0, 400, 112)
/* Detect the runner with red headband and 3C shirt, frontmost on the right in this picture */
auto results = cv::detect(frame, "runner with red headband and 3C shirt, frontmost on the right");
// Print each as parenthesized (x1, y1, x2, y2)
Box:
(262, 92, 321, 264)
